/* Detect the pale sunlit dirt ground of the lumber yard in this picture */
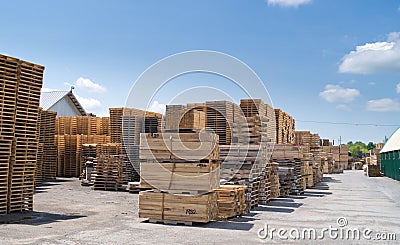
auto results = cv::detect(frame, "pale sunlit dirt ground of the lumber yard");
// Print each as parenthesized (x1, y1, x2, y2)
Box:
(0, 171, 400, 244)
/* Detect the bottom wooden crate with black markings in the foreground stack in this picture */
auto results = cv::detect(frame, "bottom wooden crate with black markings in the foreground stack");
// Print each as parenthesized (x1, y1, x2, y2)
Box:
(139, 190, 218, 225)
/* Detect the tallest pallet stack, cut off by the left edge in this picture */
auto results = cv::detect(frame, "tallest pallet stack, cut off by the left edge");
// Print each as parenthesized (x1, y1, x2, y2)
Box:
(0, 55, 44, 214)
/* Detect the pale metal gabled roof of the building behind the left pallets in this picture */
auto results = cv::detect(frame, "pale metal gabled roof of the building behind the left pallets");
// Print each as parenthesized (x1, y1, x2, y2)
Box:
(40, 90, 86, 116)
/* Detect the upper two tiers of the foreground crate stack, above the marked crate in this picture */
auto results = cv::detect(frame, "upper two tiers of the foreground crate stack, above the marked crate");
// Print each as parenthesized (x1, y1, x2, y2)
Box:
(140, 132, 220, 193)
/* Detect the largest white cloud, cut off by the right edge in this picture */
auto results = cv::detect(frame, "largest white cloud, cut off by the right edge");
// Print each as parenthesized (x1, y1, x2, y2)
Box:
(339, 32, 400, 74)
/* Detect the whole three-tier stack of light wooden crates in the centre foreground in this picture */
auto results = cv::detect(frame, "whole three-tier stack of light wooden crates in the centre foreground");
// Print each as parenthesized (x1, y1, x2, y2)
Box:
(139, 132, 220, 224)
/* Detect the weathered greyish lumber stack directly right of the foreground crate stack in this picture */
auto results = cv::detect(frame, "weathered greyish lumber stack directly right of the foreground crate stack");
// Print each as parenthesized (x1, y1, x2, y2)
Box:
(220, 145, 267, 210)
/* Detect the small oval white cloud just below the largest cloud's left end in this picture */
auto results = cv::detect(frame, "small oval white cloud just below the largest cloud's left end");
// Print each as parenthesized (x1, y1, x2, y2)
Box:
(319, 84, 360, 103)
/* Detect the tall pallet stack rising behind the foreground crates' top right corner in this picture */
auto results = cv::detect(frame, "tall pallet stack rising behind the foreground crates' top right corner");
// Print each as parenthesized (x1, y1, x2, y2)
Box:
(206, 101, 235, 145)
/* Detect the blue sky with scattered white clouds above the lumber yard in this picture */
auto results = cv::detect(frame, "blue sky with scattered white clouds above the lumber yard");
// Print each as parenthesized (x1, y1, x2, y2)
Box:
(0, 0, 400, 142)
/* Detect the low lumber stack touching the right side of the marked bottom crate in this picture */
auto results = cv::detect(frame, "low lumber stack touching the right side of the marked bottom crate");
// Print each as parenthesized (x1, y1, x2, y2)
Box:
(215, 185, 246, 219)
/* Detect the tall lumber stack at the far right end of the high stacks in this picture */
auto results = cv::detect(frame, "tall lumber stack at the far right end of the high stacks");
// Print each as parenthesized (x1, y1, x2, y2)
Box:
(275, 109, 295, 144)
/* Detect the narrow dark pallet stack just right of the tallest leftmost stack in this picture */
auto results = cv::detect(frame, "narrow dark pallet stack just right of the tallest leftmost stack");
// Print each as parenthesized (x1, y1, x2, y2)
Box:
(35, 108, 57, 184)
